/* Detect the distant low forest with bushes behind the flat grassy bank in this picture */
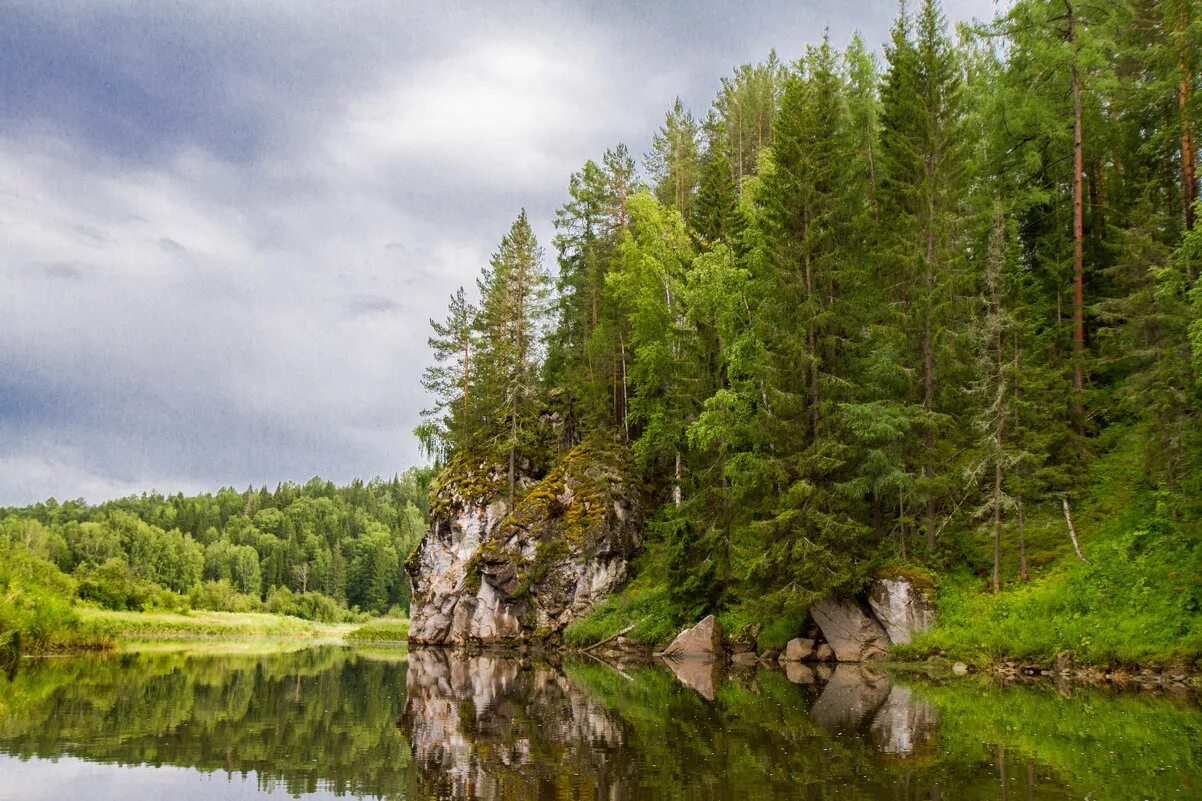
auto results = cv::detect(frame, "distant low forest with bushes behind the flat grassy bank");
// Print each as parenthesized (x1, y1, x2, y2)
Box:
(0, 468, 428, 622)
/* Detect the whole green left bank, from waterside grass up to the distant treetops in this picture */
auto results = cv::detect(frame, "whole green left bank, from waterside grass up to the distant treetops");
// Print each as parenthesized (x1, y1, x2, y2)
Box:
(0, 469, 428, 654)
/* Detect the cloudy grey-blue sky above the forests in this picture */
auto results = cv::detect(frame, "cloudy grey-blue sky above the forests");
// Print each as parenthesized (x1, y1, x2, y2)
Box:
(0, 0, 994, 504)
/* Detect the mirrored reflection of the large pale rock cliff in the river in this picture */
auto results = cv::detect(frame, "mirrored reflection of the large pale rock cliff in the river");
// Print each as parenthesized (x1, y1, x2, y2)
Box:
(401, 649, 637, 800)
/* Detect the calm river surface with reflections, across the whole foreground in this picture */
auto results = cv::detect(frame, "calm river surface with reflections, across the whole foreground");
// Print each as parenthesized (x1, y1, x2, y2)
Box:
(0, 646, 1202, 801)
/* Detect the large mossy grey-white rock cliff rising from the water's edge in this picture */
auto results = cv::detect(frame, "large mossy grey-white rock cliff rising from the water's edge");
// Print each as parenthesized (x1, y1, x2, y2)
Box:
(405, 438, 643, 645)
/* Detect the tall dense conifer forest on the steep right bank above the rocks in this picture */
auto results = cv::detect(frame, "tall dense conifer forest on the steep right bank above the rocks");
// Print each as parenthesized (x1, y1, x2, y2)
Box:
(417, 0, 1202, 659)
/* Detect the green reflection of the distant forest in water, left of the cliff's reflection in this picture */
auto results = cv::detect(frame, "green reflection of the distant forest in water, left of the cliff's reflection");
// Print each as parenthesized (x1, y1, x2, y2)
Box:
(0, 648, 412, 797)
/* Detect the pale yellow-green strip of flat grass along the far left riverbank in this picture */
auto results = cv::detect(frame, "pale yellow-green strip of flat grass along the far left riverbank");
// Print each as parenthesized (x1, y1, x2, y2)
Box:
(78, 607, 353, 640)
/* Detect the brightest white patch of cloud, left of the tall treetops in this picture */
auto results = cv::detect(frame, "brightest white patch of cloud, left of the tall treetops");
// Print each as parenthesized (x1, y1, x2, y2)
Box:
(343, 37, 613, 190)
